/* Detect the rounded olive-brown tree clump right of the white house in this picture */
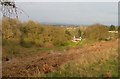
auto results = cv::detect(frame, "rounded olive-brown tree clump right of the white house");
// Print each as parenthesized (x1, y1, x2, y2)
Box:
(85, 24, 108, 40)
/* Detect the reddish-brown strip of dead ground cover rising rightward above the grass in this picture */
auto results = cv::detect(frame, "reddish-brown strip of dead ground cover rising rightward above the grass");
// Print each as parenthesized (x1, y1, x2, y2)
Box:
(3, 40, 118, 77)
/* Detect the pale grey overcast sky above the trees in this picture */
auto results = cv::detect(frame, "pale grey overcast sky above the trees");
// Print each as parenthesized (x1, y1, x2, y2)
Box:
(17, 2, 118, 25)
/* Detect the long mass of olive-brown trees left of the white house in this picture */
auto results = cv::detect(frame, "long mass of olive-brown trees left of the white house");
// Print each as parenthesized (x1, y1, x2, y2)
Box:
(2, 19, 71, 47)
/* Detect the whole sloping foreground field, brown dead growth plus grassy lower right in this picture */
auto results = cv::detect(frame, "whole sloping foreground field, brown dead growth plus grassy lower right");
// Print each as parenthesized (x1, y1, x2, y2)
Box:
(3, 40, 118, 77)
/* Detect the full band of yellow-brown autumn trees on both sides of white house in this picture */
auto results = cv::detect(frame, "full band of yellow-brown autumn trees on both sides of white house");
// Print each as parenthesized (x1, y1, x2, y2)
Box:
(2, 18, 117, 48)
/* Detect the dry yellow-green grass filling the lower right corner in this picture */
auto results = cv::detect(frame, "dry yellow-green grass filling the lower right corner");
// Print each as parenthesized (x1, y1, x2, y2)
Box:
(44, 48, 118, 77)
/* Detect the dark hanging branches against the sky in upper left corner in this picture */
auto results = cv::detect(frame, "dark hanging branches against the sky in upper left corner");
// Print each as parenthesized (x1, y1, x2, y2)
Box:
(0, 0, 29, 18)
